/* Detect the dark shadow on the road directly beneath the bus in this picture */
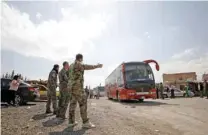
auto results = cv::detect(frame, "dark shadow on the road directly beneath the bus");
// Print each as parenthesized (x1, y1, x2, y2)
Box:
(112, 99, 178, 107)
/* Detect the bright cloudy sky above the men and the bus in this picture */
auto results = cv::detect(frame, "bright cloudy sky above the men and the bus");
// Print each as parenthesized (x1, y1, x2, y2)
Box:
(1, 0, 208, 87)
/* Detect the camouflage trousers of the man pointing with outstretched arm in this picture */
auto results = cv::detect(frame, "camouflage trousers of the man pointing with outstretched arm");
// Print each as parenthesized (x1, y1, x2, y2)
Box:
(69, 90, 89, 124)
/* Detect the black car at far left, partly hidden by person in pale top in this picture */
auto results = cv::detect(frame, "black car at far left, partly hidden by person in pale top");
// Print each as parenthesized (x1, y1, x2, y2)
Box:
(1, 78, 40, 105)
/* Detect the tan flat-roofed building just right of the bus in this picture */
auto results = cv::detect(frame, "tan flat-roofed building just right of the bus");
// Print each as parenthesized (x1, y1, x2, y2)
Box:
(163, 72, 197, 89)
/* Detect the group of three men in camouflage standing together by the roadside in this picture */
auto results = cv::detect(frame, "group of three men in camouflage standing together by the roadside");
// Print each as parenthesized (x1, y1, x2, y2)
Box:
(46, 54, 103, 128)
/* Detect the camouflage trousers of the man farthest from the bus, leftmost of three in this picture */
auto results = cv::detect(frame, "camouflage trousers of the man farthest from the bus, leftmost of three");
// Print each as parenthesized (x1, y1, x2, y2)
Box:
(46, 87, 57, 112)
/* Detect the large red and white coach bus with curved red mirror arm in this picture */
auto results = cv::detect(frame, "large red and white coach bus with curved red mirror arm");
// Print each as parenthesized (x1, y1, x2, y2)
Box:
(105, 60, 159, 101)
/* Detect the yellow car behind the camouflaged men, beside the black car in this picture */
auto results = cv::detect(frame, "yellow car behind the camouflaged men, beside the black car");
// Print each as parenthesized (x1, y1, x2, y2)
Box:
(35, 84, 59, 100)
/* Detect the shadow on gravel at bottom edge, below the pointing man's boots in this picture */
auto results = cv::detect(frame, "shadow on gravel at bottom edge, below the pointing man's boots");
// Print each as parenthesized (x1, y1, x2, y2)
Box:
(49, 128, 87, 135)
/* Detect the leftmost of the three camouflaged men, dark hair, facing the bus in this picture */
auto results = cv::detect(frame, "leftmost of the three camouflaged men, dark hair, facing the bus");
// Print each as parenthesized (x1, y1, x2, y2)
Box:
(46, 64, 59, 114)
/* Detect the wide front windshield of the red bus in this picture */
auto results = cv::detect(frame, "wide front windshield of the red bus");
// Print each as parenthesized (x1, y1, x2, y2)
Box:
(125, 63, 154, 81)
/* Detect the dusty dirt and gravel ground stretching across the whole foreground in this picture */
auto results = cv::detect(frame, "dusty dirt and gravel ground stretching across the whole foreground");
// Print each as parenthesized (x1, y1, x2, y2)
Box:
(1, 98, 208, 135)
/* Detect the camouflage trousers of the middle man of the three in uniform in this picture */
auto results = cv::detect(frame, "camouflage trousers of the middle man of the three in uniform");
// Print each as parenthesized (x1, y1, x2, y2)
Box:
(57, 88, 70, 118)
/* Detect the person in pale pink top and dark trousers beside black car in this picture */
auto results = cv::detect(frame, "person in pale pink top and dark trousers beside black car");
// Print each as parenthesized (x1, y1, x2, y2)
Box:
(7, 75, 20, 106)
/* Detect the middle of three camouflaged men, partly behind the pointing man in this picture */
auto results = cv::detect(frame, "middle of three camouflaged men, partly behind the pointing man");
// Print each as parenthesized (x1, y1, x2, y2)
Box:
(56, 61, 70, 119)
